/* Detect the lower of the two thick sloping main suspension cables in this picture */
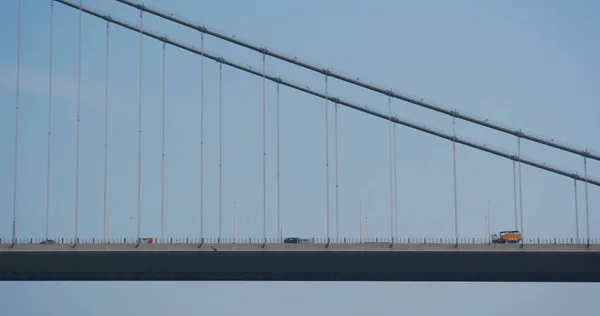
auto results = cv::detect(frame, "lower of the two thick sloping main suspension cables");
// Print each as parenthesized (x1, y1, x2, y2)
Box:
(55, 0, 600, 186)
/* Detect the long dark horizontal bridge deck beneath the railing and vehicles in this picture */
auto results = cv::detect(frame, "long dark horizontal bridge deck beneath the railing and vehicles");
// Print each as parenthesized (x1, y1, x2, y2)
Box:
(0, 243, 600, 282)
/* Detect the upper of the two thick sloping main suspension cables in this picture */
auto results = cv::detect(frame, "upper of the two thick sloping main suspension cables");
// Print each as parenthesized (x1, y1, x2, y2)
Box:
(116, 0, 600, 161)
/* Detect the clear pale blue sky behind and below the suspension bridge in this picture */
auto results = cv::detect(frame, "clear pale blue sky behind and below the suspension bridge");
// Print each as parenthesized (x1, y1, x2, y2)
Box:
(0, 0, 600, 315)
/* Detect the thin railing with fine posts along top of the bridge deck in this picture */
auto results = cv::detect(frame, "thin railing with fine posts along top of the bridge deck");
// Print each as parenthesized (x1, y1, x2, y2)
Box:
(0, 237, 600, 245)
